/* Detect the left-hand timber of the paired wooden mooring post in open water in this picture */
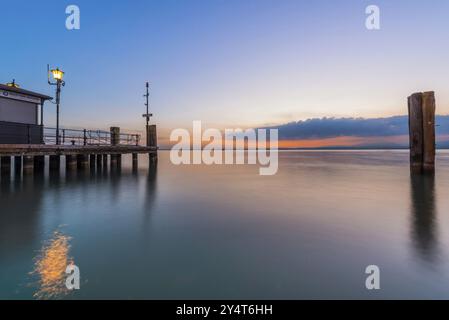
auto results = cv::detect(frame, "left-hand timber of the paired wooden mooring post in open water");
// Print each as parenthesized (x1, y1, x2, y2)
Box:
(408, 93, 424, 168)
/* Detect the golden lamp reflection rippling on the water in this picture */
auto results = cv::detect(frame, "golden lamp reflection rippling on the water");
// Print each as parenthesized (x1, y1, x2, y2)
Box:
(31, 231, 73, 300)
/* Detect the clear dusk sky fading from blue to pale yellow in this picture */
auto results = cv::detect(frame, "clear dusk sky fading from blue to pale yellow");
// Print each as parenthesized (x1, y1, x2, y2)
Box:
(0, 0, 449, 145)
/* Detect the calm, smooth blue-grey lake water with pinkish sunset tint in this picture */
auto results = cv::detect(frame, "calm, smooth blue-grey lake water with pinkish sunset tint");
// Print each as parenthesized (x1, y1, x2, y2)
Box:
(0, 151, 449, 299)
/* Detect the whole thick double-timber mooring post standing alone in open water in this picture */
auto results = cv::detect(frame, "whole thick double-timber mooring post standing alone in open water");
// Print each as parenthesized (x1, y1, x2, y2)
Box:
(408, 92, 435, 172)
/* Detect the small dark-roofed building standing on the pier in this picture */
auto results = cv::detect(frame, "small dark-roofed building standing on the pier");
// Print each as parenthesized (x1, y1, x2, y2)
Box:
(0, 82, 52, 144)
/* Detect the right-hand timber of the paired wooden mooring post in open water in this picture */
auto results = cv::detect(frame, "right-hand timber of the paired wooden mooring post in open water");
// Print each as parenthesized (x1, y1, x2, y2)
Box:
(422, 91, 436, 171)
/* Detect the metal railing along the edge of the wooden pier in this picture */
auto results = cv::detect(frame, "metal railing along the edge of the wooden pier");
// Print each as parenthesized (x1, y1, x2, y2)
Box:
(44, 127, 140, 146)
